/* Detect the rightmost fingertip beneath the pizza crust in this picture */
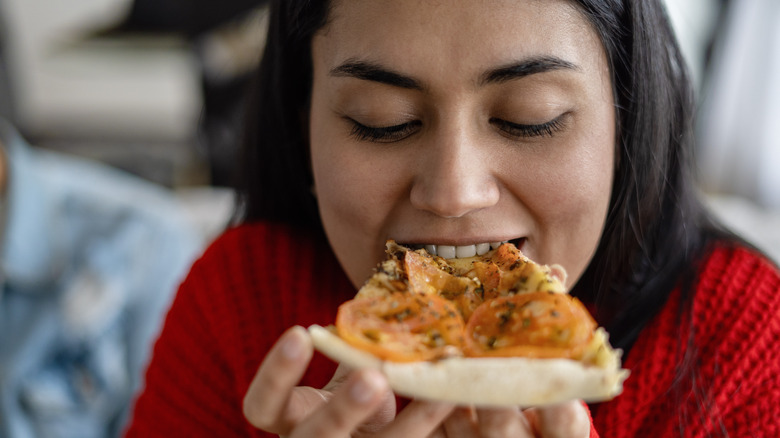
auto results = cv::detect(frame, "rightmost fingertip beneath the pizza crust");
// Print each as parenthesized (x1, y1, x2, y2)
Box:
(526, 401, 590, 438)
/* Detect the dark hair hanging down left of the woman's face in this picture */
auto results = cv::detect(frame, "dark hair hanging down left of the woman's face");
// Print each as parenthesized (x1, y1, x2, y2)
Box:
(233, 0, 329, 231)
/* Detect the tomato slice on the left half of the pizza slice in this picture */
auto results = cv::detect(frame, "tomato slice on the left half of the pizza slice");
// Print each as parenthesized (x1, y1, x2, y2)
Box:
(336, 292, 465, 362)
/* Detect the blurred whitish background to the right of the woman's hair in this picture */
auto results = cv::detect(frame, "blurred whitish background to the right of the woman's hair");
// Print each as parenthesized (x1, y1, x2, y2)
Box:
(666, 0, 780, 261)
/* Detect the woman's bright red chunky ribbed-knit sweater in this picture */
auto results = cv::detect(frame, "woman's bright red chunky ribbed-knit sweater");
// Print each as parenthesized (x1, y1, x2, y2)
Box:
(123, 224, 780, 437)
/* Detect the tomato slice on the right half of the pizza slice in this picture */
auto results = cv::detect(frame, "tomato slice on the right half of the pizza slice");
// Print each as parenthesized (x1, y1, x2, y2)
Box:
(464, 292, 596, 359)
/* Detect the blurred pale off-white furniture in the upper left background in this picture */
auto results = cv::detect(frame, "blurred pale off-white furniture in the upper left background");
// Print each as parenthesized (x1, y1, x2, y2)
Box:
(0, 0, 200, 141)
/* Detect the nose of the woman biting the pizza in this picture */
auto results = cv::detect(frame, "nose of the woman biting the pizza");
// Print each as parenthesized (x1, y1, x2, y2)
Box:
(410, 130, 500, 218)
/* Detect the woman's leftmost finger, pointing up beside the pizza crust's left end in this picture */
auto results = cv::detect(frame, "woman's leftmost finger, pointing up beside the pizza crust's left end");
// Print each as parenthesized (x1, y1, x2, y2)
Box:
(244, 326, 321, 434)
